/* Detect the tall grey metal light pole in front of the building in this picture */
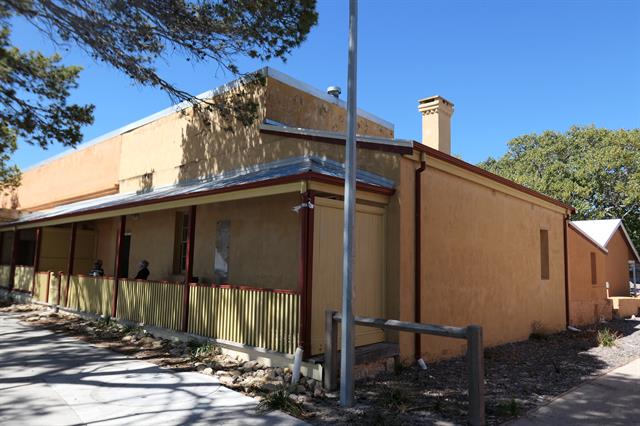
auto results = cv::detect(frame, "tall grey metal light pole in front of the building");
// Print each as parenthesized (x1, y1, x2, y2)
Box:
(340, 0, 358, 407)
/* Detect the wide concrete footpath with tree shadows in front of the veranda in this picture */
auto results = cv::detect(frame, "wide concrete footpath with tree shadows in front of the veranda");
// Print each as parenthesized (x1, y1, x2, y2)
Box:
(0, 313, 304, 426)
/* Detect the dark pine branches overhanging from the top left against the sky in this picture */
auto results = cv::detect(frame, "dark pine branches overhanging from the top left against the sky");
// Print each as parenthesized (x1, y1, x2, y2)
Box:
(0, 0, 317, 188)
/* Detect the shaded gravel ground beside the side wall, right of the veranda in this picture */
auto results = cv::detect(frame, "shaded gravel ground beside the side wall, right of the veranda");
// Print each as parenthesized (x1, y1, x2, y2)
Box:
(302, 320, 640, 426)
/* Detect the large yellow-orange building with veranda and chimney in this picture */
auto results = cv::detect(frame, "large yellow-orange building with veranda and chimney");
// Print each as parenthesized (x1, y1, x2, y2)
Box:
(0, 69, 572, 359)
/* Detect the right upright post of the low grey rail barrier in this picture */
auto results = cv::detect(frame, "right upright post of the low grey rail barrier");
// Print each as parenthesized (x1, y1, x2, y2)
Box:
(467, 325, 484, 426)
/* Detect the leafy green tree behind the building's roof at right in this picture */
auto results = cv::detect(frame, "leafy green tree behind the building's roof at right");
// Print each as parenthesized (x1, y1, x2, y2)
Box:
(479, 126, 640, 247)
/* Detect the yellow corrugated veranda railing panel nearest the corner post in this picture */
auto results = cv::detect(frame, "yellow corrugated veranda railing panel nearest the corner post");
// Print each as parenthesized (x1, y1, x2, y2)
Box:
(188, 285, 300, 353)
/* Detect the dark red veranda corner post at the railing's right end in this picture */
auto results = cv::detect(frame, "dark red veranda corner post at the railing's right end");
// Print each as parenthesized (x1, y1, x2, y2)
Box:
(298, 191, 315, 359)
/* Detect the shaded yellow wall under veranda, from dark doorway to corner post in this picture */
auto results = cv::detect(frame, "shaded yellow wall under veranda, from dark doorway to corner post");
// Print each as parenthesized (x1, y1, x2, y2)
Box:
(126, 194, 300, 290)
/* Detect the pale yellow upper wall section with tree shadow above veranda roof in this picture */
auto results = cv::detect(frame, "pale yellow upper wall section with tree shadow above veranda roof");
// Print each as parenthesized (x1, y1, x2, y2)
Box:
(119, 86, 265, 192)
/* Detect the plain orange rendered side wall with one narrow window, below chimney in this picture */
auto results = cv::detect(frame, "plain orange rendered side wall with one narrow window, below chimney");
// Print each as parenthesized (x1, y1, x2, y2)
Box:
(410, 166, 565, 359)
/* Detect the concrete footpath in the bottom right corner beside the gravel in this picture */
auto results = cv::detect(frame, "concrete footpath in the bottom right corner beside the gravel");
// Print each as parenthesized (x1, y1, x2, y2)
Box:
(510, 359, 640, 426)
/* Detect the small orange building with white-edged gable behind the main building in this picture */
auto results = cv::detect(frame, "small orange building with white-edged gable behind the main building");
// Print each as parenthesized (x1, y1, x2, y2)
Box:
(567, 219, 640, 325)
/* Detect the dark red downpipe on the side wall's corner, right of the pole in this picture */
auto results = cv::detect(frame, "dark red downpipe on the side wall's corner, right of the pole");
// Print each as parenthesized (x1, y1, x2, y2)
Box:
(413, 161, 427, 359)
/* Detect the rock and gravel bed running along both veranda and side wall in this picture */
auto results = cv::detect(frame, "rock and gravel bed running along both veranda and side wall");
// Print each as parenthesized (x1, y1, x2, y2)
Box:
(5, 305, 640, 426)
